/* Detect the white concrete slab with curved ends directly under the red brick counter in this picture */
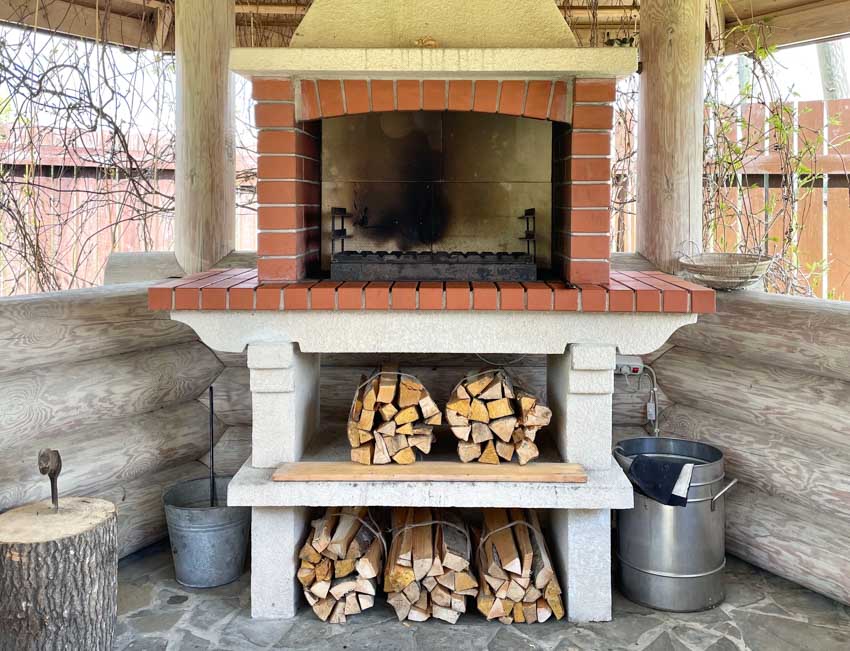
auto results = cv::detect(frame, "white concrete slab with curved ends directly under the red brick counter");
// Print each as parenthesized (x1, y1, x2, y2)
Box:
(171, 310, 697, 355)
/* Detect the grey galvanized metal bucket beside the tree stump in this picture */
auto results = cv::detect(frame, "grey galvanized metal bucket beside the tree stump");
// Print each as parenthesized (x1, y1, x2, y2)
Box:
(162, 477, 251, 588)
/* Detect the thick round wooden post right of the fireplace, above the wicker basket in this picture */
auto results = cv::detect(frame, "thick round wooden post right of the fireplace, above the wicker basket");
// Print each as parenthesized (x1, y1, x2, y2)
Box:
(638, 0, 705, 272)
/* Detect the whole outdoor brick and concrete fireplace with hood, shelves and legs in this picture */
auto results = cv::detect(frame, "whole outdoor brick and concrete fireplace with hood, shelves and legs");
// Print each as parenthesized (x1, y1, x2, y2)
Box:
(149, 0, 714, 621)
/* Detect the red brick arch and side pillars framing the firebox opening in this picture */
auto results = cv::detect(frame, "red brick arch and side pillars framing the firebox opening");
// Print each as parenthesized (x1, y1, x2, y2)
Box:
(253, 78, 616, 286)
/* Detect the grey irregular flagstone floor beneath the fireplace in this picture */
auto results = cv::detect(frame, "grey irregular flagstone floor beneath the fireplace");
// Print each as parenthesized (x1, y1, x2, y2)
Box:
(116, 544, 850, 651)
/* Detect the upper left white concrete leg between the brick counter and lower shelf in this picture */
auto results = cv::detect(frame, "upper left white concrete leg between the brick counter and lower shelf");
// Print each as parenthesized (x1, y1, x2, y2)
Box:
(248, 342, 319, 468)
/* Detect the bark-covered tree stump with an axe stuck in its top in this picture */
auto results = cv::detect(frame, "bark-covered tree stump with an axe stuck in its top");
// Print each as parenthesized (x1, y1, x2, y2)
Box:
(0, 497, 118, 651)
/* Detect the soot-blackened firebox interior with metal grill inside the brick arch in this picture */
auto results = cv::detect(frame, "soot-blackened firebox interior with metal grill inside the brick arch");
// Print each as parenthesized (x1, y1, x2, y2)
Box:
(322, 111, 552, 281)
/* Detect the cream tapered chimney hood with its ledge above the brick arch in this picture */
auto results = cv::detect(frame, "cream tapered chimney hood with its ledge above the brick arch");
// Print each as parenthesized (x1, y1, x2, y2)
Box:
(231, 0, 637, 80)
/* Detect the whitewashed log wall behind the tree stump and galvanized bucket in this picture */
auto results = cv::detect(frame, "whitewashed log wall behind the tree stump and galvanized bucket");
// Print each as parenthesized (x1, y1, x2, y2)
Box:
(0, 284, 235, 556)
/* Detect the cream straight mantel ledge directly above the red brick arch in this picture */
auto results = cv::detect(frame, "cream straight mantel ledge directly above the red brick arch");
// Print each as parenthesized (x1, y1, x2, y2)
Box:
(230, 47, 637, 79)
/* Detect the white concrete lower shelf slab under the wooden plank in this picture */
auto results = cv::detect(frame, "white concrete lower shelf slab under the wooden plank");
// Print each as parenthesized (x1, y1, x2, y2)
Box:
(227, 461, 634, 509)
